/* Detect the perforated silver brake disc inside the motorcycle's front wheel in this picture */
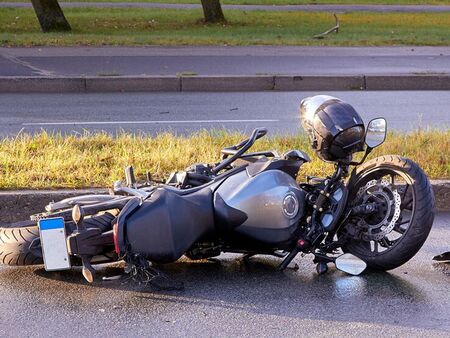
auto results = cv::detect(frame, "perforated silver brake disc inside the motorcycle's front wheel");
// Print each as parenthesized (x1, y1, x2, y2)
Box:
(357, 179, 401, 241)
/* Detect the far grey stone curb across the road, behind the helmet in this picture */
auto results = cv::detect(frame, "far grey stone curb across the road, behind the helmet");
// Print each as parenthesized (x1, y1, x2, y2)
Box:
(0, 74, 450, 93)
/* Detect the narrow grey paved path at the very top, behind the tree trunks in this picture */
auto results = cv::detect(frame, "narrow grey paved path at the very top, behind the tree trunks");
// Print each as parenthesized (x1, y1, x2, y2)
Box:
(0, 1, 450, 13)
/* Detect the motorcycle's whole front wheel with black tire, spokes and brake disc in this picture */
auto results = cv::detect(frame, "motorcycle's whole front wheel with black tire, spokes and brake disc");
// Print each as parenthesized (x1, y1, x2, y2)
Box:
(341, 155, 435, 270)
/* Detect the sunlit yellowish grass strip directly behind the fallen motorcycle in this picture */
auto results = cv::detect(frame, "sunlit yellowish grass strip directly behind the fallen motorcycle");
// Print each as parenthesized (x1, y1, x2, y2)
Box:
(0, 130, 450, 189)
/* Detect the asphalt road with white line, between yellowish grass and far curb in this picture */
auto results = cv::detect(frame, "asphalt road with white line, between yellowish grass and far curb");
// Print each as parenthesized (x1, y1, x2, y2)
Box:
(0, 91, 450, 137)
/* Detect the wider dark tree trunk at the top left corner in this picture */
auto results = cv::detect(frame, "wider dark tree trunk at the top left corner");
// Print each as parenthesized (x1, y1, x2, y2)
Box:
(31, 0, 71, 32)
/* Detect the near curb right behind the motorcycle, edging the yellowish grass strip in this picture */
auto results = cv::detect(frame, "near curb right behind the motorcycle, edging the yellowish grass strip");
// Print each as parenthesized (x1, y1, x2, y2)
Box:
(0, 180, 450, 224)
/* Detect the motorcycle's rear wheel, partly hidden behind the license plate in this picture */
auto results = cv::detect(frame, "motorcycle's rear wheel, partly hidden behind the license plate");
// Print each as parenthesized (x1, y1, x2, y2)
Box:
(0, 212, 115, 265)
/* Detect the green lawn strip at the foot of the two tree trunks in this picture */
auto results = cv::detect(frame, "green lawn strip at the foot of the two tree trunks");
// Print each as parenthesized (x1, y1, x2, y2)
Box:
(0, 8, 450, 46)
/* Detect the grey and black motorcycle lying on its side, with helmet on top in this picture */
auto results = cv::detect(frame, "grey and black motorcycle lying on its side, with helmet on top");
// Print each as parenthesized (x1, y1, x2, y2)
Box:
(0, 95, 434, 282)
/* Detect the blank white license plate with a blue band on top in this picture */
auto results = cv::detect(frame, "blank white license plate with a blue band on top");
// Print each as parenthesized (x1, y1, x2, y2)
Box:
(38, 217, 70, 271)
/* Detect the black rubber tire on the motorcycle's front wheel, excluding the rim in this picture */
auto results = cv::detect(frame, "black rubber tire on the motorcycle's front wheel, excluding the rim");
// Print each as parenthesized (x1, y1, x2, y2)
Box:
(343, 155, 435, 271)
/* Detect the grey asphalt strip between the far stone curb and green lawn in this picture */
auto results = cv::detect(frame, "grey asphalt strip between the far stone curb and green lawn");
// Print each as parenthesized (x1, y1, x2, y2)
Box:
(0, 46, 450, 76)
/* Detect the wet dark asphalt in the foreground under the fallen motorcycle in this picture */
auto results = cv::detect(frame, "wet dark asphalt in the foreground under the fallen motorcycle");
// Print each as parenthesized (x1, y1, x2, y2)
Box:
(0, 213, 450, 337)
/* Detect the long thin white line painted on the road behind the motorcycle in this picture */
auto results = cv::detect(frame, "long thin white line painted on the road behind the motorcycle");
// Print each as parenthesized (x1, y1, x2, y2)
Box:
(22, 120, 280, 126)
